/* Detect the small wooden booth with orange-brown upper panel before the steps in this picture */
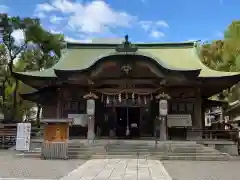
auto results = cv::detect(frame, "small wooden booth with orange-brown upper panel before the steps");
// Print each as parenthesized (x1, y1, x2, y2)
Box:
(41, 119, 72, 159)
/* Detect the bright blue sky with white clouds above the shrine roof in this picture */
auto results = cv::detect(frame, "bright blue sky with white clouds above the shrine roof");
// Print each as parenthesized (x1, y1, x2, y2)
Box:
(0, 0, 240, 42)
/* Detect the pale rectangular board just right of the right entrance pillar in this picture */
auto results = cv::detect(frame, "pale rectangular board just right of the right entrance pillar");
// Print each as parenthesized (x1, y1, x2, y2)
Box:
(167, 114, 192, 127)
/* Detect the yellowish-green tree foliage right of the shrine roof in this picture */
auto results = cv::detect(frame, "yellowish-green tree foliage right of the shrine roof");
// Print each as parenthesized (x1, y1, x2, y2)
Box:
(200, 21, 240, 100)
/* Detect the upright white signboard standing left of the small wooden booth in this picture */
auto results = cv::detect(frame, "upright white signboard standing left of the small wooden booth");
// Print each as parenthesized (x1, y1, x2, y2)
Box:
(16, 123, 31, 151)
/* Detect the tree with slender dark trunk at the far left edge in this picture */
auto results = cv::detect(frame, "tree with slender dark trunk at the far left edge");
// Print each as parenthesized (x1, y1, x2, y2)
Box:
(0, 14, 40, 118)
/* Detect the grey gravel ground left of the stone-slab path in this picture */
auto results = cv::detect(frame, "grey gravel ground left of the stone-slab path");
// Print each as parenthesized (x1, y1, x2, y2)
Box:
(0, 150, 85, 179)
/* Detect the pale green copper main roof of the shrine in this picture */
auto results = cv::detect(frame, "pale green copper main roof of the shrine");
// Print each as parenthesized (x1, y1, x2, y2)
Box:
(14, 42, 239, 77)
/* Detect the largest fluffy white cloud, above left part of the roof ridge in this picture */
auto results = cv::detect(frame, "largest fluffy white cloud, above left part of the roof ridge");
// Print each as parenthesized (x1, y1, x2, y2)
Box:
(36, 0, 134, 33)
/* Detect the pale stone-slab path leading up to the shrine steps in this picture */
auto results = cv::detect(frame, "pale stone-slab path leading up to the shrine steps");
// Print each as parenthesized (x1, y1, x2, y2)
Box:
(60, 159, 172, 180)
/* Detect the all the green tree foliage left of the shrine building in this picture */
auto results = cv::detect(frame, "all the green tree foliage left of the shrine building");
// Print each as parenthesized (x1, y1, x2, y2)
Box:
(0, 14, 64, 119)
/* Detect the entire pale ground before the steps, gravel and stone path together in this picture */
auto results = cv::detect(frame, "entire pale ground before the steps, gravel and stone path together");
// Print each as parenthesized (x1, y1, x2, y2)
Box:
(0, 148, 240, 180)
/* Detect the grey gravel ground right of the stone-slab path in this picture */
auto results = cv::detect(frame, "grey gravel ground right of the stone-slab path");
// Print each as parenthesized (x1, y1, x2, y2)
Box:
(161, 161, 240, 180)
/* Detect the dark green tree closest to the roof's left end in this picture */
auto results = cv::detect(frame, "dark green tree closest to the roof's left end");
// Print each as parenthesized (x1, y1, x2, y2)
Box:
(18, 30, 64, 125)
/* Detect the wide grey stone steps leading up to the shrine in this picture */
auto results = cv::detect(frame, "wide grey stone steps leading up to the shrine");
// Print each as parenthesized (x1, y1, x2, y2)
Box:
(15, 140, 232, 161)
